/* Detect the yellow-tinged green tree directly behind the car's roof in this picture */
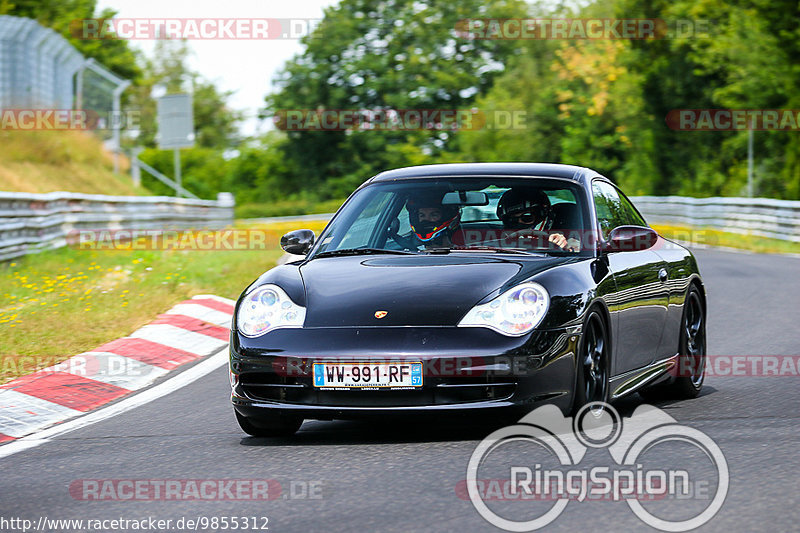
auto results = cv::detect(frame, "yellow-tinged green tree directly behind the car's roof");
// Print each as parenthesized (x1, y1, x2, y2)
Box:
(450, 4, 663, 192)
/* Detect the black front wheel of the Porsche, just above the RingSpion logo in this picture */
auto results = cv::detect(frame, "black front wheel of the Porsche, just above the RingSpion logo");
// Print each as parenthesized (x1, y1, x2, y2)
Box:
(572, 310, 611, 414)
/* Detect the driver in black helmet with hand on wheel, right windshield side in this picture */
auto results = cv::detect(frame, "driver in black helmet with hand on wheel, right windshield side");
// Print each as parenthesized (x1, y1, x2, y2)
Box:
(497, 189, 580, 252)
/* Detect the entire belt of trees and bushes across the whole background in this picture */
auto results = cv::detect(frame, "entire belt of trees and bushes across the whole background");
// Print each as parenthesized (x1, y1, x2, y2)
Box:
(0, 0, 800, 205)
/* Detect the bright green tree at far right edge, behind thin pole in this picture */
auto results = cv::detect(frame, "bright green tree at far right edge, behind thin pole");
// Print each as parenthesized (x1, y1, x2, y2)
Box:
(669, 0, 800, 199)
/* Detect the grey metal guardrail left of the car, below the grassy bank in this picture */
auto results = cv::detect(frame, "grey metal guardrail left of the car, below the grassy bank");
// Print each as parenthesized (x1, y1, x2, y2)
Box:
(0, 192, 234, 261)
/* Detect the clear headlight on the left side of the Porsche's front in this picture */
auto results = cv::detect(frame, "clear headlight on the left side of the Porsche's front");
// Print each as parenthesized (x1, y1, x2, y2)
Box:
(236, 285, 306, 337)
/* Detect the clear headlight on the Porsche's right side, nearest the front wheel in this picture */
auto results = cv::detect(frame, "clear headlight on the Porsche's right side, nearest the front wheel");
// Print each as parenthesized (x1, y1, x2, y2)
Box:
(458, 282, 550, 337)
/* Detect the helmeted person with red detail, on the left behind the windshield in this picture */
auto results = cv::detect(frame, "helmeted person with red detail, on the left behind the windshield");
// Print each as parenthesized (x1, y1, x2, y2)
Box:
(406, 193, 461, 248)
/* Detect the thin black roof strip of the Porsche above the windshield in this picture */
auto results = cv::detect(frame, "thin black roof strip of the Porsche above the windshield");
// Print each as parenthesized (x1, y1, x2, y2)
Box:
(369, 163, 598, 183)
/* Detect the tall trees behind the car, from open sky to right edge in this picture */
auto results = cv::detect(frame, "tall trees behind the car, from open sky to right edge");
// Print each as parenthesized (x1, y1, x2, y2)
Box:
(267, 0, 800, 199)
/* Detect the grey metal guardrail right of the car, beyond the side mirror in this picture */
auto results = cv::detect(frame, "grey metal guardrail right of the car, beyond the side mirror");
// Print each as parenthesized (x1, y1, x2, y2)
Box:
(631, 196, 800, 242)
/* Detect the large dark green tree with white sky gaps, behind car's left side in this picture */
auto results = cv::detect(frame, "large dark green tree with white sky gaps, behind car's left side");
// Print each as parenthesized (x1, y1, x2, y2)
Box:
(266, 0, 526, 197)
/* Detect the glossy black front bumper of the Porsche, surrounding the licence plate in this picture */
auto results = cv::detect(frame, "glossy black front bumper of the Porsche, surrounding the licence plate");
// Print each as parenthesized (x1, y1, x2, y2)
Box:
(230, 327, 579, 419)
